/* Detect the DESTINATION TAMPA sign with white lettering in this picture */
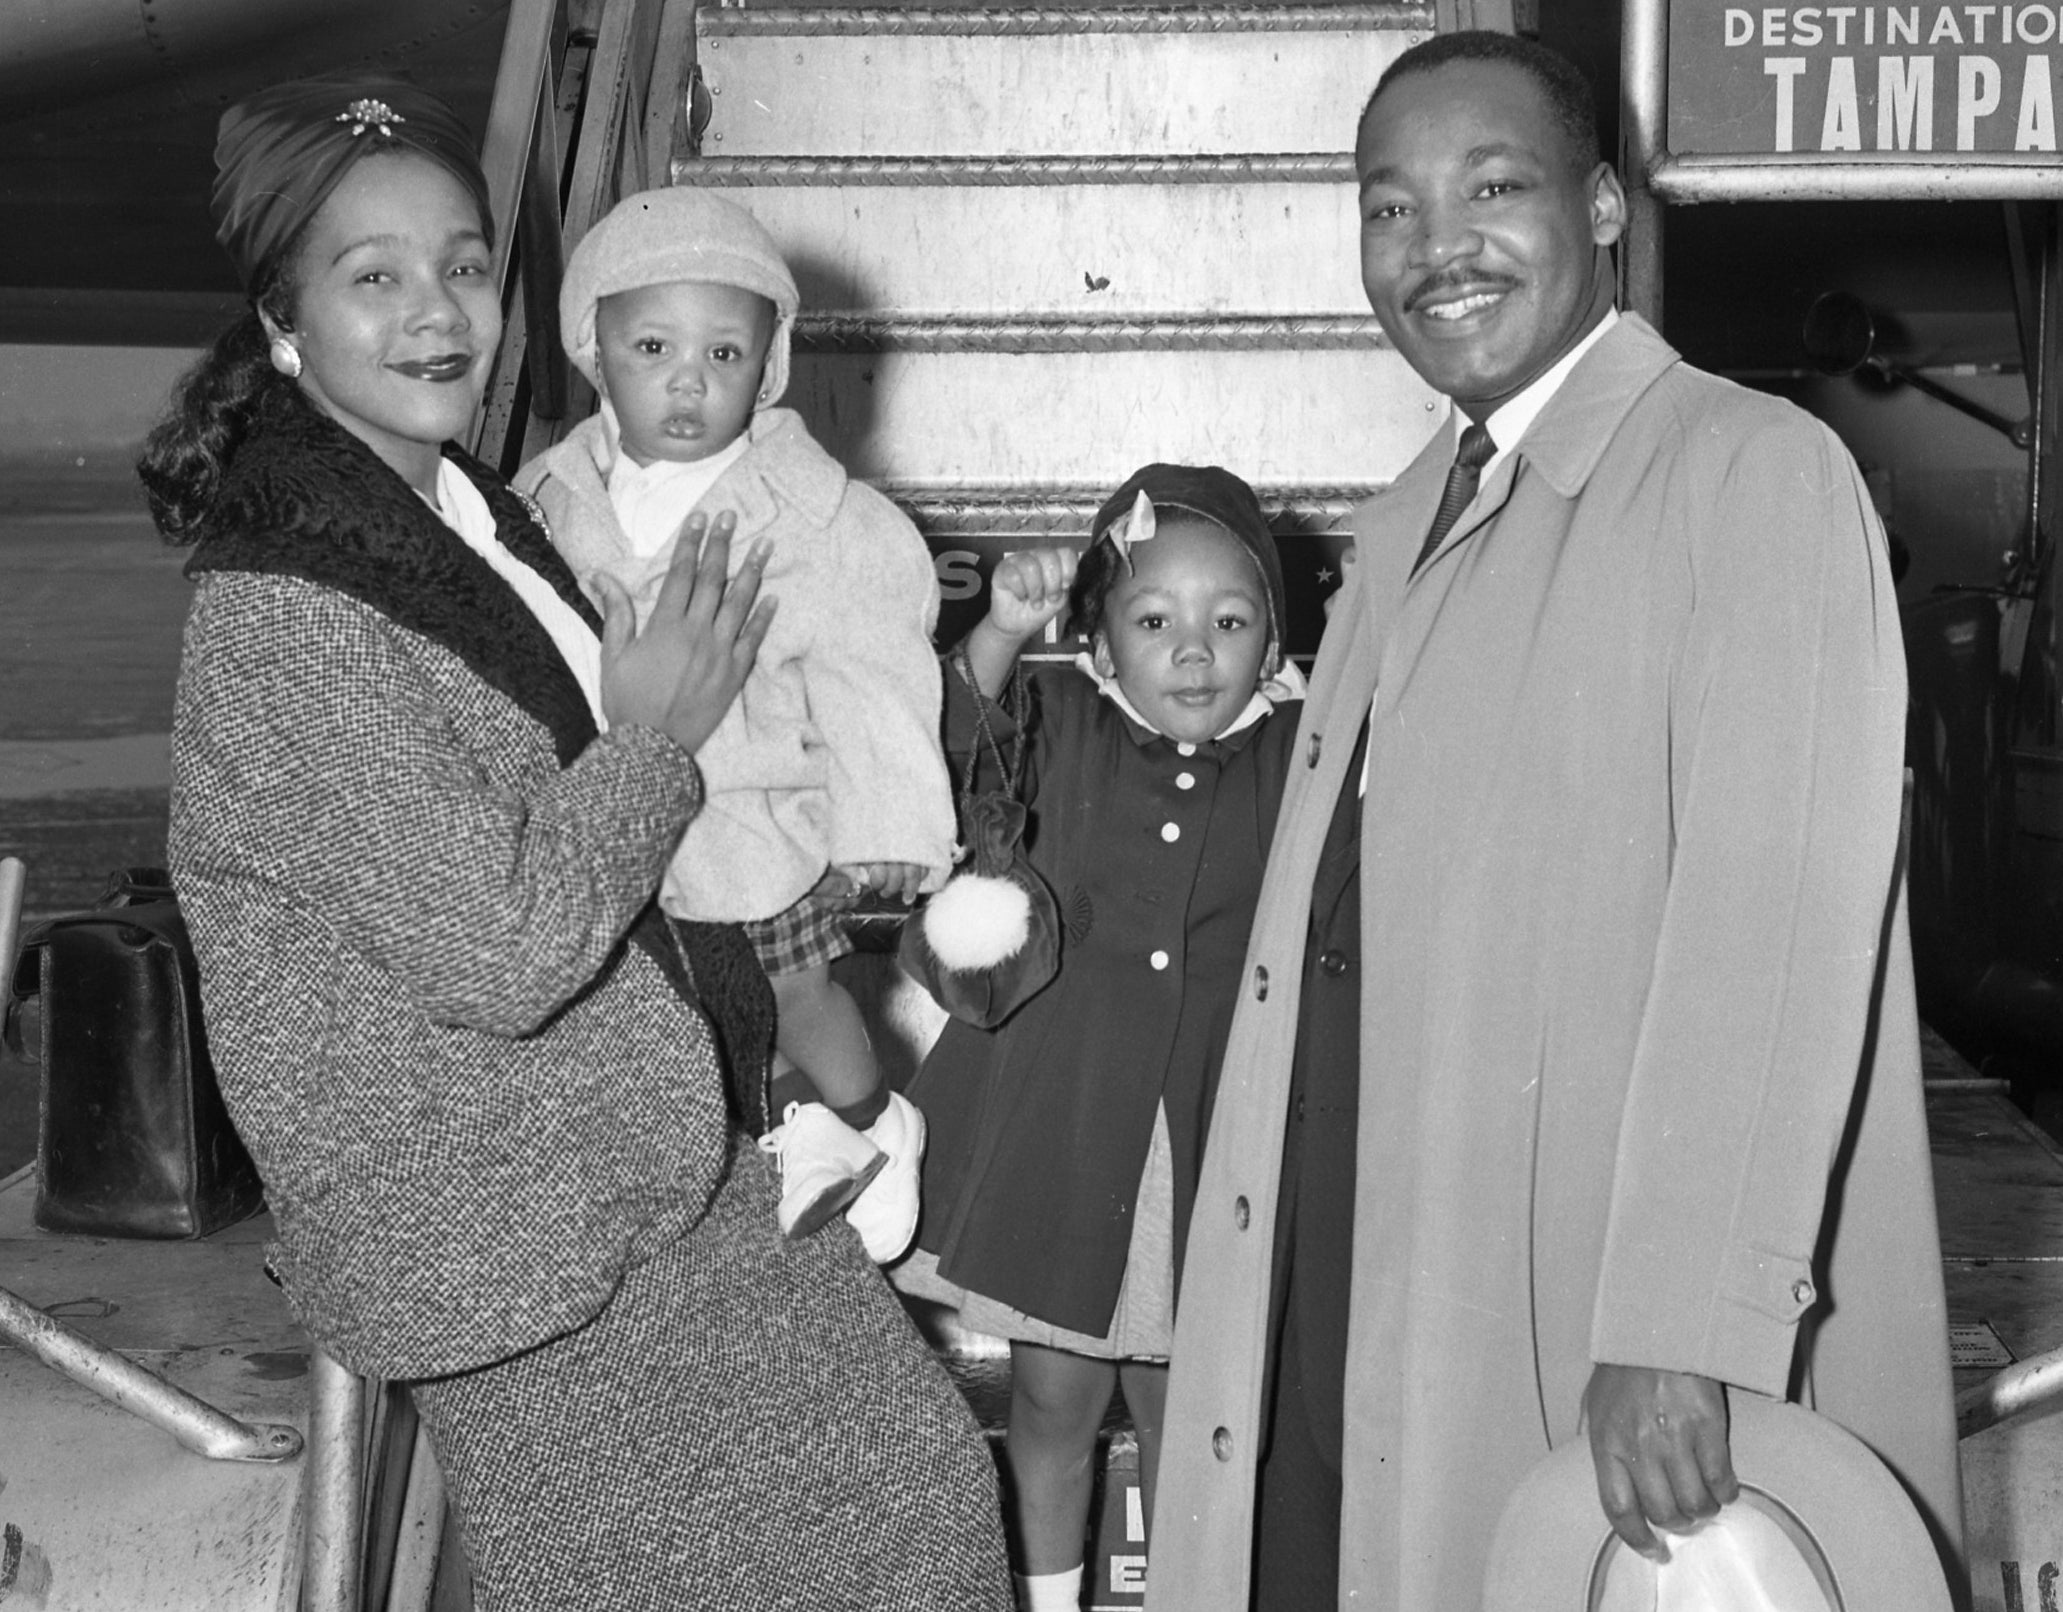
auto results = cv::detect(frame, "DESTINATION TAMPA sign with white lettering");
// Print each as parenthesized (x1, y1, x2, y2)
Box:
(1667, 0, 2063, 161)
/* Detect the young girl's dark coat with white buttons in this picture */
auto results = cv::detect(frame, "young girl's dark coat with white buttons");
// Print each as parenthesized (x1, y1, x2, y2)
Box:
(910, 669, 1296, 1335)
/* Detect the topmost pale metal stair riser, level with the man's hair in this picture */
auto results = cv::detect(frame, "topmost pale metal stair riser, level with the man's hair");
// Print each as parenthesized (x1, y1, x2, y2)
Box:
(697, 4, 1432, 157)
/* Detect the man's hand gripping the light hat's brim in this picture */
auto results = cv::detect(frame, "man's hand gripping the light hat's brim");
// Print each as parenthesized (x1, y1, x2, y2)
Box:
(1582, 1366, 1741, 1562)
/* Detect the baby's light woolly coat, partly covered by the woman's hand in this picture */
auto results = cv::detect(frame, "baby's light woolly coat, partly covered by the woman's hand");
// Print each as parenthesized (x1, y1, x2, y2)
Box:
(516, 409, 953, 918)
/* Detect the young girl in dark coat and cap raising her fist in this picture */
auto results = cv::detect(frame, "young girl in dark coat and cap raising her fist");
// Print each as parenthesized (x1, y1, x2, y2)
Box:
(895, 464, 1302, 1610)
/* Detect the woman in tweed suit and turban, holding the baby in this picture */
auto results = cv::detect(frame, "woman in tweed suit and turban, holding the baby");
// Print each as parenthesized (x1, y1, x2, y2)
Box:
(140, 76, 1009, 1608)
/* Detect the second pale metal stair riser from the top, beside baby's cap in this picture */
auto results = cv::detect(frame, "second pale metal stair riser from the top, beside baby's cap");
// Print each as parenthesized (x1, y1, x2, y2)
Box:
(675, 180, 1368, 318)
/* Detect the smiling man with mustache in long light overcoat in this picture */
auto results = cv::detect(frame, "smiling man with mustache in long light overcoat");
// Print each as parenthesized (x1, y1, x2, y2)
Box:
(1149, 33, 1960, 1612)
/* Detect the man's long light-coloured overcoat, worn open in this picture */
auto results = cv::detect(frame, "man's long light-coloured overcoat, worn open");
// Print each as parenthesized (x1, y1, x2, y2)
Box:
(1149, 307, 1960, 1612)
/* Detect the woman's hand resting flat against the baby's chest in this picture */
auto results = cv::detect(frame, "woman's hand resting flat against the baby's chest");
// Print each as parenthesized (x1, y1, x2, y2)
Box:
(592, 510, 776, 751)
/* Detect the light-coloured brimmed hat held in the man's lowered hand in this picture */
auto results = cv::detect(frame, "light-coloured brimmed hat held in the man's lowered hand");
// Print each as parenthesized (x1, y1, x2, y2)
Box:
(1483, 1389, 1950, 1612)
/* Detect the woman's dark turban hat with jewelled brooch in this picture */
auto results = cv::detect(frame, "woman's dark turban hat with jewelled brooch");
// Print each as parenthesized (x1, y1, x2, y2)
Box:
(210, 72, 493, 291)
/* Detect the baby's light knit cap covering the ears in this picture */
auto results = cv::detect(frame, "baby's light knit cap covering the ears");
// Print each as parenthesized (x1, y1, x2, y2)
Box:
(559, 186, 803, 402)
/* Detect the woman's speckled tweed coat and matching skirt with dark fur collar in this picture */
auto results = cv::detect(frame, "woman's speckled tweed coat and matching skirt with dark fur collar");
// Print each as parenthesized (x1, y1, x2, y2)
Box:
(171, 394, 1007, 1608)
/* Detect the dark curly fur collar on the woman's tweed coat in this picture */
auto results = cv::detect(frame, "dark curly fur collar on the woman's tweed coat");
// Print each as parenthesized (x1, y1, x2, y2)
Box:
(186, 388, 600, 766)
